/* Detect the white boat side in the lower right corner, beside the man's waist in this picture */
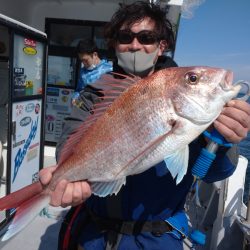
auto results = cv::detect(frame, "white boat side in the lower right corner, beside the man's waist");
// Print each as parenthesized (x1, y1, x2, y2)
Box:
(184, 156, 250, 250)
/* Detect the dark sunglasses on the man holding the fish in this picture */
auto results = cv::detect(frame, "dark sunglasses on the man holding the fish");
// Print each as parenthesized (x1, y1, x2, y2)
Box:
(117, 30, 160, 45)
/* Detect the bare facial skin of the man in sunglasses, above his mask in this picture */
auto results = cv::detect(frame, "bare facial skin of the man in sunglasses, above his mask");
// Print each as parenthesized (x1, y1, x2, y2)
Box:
(116, 17, 166, 56)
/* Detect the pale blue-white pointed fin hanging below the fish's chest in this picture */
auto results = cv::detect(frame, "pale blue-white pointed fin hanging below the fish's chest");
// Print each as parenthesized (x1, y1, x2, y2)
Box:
(164, 145, 189, 184)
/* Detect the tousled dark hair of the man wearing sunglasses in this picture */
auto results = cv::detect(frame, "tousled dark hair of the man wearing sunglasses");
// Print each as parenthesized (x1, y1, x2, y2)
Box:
(104, 1, 175, 50)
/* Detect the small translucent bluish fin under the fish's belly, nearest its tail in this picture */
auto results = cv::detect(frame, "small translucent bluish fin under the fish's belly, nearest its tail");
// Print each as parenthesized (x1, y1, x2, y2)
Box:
(91, 177, 126, 197)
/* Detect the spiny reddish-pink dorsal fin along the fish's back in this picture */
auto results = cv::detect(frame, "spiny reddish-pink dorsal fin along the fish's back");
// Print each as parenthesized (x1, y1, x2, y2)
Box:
(58, 72, 140, 167)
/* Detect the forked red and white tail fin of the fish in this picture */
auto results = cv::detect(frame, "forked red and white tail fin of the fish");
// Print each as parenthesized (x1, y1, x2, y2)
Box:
(0, 182, 50, 241)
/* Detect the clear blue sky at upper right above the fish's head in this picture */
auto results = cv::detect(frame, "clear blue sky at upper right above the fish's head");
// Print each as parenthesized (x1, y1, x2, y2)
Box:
(175, 0, 250, 81)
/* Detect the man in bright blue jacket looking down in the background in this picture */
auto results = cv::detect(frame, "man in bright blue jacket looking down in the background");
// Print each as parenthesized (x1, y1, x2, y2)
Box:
(72, 39, 112, 104)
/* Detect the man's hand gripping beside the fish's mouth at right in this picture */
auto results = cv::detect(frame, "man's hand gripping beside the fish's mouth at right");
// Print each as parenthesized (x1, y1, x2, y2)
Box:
(214, 100, 250, 143)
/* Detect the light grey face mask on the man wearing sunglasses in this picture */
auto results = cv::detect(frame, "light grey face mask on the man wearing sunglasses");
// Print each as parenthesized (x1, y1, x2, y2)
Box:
(116, 49, 159, 77)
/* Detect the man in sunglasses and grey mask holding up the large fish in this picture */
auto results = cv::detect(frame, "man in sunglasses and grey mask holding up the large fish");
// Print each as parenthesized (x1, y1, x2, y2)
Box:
(40, 2, 250, 250)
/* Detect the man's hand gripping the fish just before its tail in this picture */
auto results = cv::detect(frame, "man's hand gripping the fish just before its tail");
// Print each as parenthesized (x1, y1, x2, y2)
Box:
(39, 167, 91, 207)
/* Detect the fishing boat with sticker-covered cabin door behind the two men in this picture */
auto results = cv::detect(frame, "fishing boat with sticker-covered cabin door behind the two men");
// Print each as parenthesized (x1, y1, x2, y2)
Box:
(0, 0, 250, 250)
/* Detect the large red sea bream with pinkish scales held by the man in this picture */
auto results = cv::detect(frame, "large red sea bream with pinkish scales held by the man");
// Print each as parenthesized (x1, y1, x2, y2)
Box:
(0, 67, 240, 240)
